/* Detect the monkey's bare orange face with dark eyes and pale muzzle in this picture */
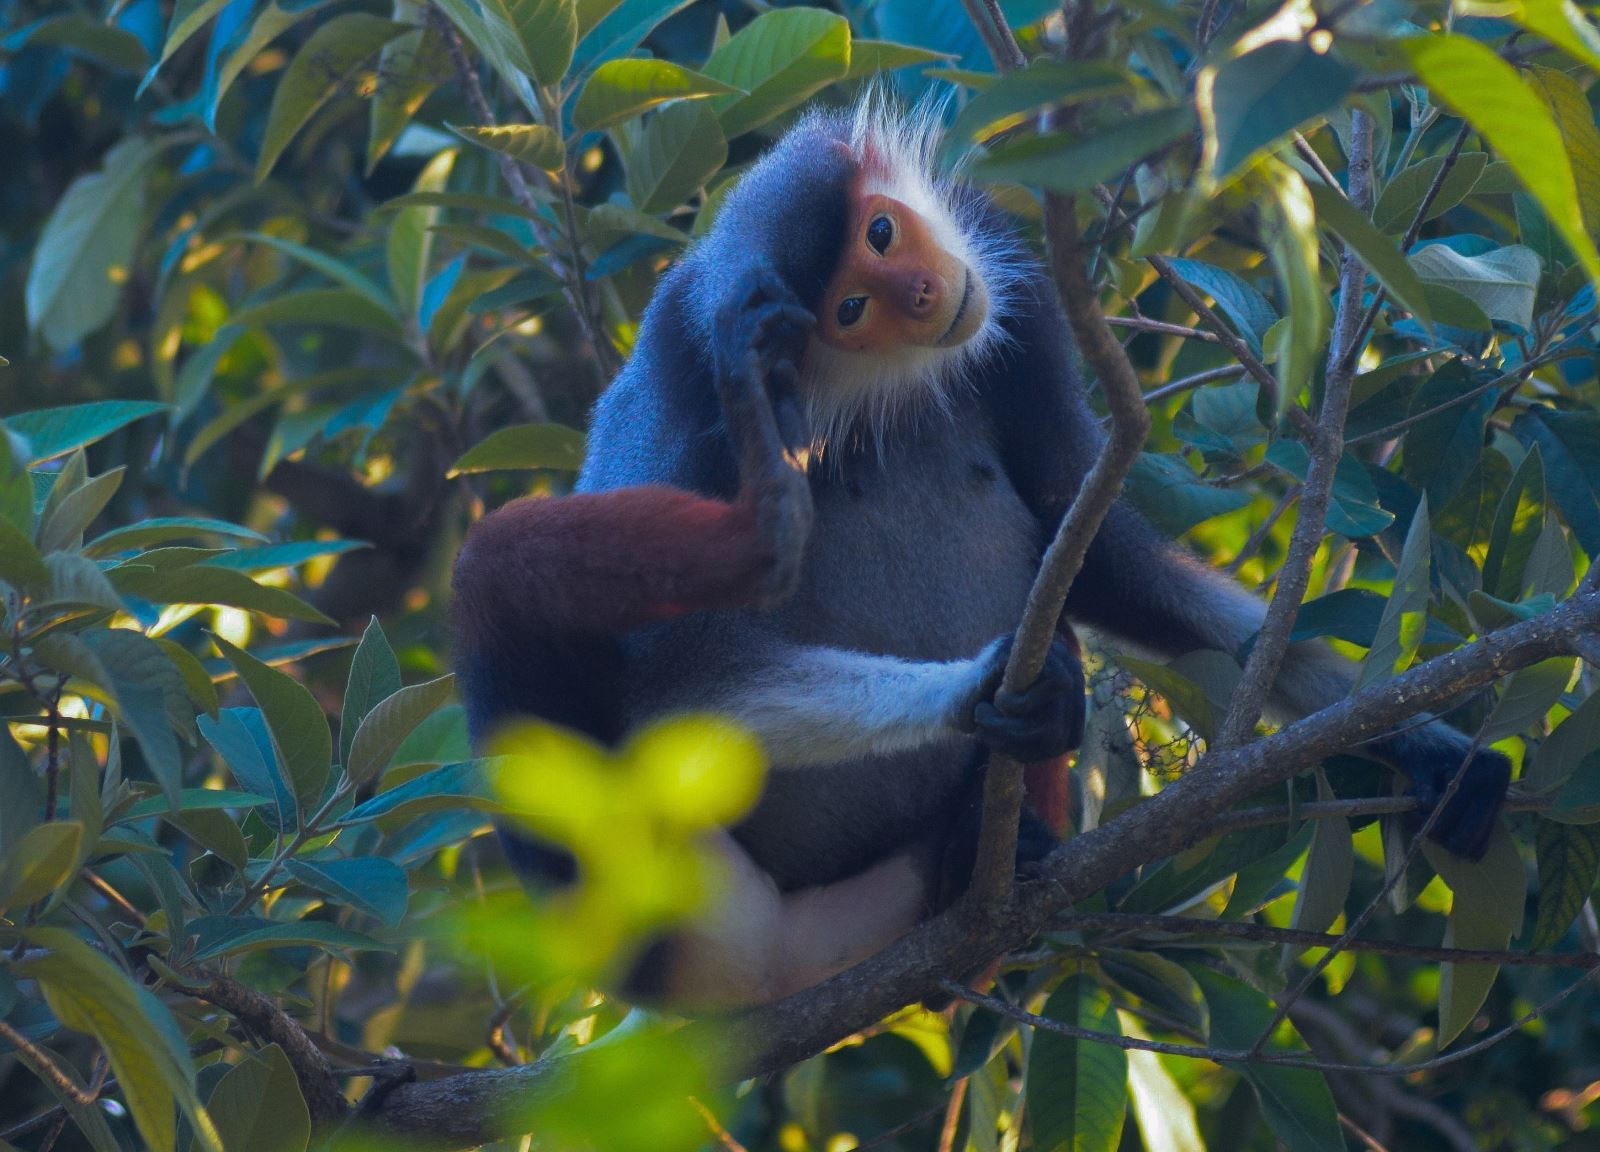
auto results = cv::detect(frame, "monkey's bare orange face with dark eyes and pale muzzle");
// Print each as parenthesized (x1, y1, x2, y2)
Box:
(816, 194, 989, 352)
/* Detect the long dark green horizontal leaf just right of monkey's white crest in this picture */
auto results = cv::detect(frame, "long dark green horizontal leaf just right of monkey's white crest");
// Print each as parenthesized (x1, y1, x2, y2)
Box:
(968, 104, 1195, 192)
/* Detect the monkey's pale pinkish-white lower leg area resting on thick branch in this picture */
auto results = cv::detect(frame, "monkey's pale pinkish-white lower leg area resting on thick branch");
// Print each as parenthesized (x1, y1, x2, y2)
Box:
(635, 835, 933, 1008)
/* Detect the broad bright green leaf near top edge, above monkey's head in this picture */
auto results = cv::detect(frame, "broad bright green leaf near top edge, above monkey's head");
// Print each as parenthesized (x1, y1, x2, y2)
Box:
(702, 8, 850, 139)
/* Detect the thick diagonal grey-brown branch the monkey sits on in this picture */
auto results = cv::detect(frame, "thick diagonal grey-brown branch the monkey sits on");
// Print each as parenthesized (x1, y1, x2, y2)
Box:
(360, 581, 1600, 1147)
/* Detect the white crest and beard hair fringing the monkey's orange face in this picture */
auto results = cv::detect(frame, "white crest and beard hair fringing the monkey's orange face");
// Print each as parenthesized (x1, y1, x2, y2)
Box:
(803, 83, 1026, 459)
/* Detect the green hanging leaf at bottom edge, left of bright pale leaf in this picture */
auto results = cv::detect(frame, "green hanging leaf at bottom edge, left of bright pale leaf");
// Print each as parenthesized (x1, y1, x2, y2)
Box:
(1027, 976, 1128, 1152)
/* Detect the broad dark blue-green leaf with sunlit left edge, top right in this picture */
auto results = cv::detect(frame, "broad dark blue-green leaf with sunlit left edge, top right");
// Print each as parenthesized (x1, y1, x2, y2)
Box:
(1198, 40, 1355, 179)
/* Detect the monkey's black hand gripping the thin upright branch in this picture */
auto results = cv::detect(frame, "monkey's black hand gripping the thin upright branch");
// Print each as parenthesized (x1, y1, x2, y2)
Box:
(971, 637, 1085, 763)
